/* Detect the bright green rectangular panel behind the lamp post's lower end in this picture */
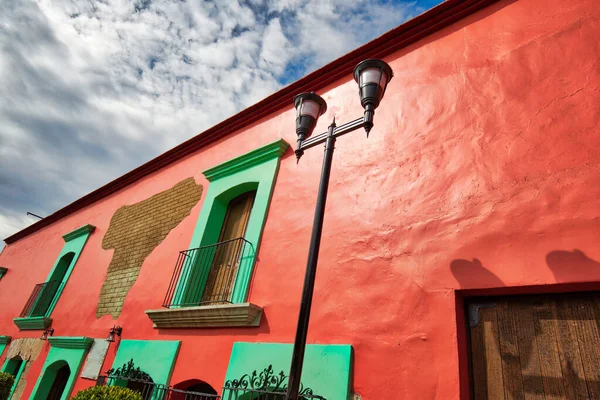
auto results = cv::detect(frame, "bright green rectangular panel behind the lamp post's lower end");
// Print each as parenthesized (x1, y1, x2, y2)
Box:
(222, 342, 352, 400)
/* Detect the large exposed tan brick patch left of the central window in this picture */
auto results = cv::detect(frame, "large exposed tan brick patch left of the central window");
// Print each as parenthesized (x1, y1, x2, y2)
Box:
(96, 178, 202, 318)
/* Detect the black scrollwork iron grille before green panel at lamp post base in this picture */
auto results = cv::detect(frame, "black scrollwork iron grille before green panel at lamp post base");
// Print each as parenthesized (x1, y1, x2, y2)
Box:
(222, 365, 326, 400)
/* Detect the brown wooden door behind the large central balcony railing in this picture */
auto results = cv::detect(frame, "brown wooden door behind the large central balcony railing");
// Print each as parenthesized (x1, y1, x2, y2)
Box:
(202, 191, 256, 303)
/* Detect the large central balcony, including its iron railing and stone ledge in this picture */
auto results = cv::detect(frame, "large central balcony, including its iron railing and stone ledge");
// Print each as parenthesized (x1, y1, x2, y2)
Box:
(146, 238, 262, 328)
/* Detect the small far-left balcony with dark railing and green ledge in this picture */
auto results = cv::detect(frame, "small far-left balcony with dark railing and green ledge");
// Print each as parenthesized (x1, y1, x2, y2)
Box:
(14, 281, 62, 330)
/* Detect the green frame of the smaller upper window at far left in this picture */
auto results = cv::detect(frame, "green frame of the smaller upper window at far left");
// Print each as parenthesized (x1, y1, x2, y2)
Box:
(13, 224, 96, 330)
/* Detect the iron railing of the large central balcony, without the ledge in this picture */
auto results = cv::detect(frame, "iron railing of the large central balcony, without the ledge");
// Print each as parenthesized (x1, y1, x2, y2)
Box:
(163, 238, 252, 308)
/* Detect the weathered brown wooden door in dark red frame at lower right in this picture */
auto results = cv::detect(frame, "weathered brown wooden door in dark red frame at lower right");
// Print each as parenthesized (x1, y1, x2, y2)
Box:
(469, 294, 600, 400)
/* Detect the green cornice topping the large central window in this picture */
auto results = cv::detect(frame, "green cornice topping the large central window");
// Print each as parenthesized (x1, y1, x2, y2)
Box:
(202, 139, 290, 182)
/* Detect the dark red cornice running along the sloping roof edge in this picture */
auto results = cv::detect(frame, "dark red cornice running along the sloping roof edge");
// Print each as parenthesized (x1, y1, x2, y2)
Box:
(4, 0, 498, 244)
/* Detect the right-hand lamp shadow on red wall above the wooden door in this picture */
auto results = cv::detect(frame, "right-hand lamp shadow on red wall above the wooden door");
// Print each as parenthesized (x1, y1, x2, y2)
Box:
(546, 249, 600, 283)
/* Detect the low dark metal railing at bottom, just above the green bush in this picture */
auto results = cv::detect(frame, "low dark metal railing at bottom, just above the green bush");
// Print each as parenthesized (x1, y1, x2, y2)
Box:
(96, 376, 221, 400)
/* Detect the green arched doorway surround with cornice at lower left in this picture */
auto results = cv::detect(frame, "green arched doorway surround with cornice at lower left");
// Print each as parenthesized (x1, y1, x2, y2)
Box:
(29, 337, 91, 400)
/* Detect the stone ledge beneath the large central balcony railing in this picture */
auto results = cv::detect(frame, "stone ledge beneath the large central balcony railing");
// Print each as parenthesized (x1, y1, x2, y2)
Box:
(146, 303, 262, 328)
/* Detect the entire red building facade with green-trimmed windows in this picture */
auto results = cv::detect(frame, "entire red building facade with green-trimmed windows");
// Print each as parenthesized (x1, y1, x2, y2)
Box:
(0, 0, 600, 400)
